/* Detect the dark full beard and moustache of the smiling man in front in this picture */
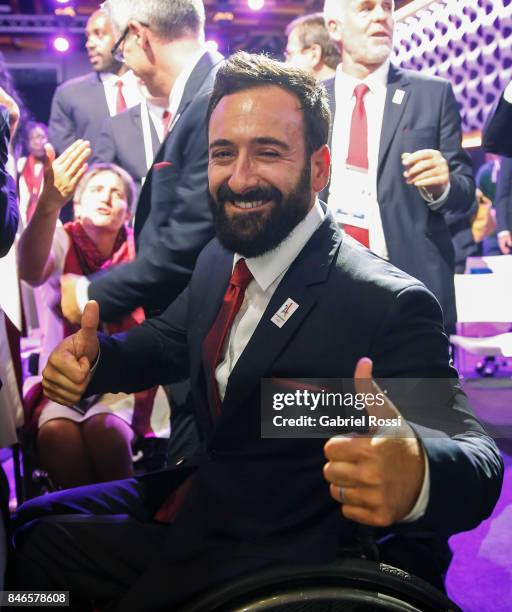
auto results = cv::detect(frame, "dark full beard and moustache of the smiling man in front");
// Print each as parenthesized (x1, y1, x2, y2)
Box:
(208, 163, 311, 257)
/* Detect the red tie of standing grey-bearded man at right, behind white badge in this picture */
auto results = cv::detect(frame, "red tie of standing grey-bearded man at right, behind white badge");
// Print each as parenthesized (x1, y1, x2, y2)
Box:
(343, 83, 370, 247)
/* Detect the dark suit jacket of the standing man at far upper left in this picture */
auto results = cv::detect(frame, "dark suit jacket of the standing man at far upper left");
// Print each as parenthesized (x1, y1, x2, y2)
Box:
(48, 72, 109, 155)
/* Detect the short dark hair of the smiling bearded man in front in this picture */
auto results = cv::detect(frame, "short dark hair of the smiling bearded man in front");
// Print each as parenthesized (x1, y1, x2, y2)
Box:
(207, 51, 331, 156)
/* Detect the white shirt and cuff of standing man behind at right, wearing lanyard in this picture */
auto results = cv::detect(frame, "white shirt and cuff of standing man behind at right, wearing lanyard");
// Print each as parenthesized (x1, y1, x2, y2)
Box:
(327, 60, 450, 259)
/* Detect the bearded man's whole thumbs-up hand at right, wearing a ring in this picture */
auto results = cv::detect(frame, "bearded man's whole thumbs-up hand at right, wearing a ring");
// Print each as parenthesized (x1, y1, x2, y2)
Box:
(324, 357, 425, 527)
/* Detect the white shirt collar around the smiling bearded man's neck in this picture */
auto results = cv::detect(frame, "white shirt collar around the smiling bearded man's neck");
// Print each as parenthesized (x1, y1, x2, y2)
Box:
(233, 198, 325, 291)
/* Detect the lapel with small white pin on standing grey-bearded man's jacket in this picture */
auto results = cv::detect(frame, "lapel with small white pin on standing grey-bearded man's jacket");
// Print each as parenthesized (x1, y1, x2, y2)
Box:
(377, 65, 410, 175)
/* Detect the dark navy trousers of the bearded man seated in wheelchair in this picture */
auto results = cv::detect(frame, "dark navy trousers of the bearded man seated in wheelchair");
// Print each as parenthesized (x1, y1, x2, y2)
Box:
(11, 477, 444, 612)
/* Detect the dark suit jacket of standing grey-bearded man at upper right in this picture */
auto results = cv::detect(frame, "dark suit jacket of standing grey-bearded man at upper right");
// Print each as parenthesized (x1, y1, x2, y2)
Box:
(326, 66, 475, 328)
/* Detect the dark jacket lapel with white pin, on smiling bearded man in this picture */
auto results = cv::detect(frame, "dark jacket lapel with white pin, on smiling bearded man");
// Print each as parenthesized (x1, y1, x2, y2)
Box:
(220, 215, 341, 428)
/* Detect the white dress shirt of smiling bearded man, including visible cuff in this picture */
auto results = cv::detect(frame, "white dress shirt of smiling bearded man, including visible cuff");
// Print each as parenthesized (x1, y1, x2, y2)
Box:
(215, 200, 430, 522)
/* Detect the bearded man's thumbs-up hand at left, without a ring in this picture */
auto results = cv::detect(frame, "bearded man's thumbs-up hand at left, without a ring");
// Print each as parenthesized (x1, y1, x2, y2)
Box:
(42, 301, 99, 406)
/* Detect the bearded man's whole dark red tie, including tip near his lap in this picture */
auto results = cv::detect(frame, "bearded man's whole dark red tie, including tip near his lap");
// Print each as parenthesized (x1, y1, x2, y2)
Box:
(155, 259, 253, 523)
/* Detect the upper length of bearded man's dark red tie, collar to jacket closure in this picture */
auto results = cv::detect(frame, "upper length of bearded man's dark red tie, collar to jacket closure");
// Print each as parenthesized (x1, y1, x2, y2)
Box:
(203, 259, 253, 415)
